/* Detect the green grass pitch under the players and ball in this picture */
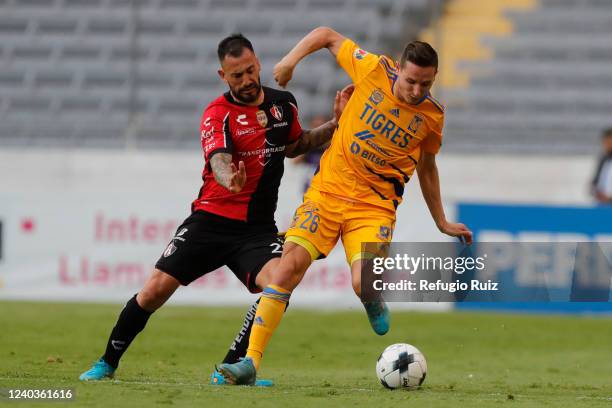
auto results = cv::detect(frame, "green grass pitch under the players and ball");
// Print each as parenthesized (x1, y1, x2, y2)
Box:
(0, 302, 612, 408)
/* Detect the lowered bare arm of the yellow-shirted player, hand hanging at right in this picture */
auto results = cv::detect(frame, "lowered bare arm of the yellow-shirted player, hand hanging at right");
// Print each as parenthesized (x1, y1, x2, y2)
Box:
(417, 152, 472, 245)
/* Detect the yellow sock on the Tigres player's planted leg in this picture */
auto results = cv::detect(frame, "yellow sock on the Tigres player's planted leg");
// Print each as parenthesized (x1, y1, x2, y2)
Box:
(247, 285, 291, 369)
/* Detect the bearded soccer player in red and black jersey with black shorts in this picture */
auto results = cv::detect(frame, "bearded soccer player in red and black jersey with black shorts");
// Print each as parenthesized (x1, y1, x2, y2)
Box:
(80, 34, 350, 385)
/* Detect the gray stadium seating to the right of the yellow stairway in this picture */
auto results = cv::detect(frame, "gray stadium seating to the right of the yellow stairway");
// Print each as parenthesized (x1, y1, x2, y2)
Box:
(443, 0, 612, 153)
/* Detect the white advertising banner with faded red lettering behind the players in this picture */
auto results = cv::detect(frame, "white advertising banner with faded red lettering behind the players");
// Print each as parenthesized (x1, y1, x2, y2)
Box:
(8, 150, 592, 308)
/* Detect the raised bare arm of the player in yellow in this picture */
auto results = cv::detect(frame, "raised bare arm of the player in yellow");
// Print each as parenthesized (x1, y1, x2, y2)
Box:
(273, 27, 345, 87)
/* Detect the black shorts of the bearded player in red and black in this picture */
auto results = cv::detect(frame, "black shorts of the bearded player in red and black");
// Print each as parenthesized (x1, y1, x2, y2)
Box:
(155, 211, 283, 293)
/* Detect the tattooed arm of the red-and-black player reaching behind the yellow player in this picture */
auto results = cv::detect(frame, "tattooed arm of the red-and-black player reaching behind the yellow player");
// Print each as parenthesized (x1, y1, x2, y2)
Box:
(285, 84, 355, 158)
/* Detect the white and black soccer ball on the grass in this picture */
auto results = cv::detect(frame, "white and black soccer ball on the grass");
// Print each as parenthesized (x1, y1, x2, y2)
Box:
(376, 343, 427, 389)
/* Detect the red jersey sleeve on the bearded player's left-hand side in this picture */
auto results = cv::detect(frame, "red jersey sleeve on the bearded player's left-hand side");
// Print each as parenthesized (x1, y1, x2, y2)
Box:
(200, 106, 232, 162)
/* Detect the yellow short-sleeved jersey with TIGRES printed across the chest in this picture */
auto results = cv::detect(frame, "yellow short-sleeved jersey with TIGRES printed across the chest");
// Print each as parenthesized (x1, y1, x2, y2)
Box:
(311, 39, 444, 211)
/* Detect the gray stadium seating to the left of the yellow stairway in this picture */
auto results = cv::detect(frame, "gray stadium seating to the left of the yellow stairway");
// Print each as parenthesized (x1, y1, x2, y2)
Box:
(0, 0, 427, 148)
